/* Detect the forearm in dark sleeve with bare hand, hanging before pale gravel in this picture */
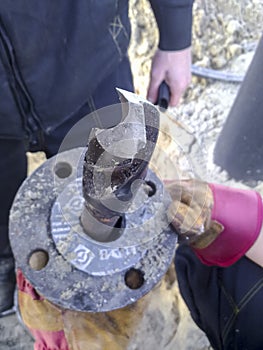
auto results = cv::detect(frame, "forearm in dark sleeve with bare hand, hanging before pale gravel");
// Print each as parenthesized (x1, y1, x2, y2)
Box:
(147, 0, 193, 106)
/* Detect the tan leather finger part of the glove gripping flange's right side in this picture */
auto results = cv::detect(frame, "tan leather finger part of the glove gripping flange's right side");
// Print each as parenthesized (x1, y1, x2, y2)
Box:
(165, 179, 223, 248)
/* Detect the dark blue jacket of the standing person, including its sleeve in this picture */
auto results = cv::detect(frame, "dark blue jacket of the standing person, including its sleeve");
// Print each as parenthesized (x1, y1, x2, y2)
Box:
(0, 0, 192, 139)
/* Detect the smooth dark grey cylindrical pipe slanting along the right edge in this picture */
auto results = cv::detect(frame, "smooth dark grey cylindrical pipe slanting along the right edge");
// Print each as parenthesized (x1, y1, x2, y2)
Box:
(214, 37, 263, 185)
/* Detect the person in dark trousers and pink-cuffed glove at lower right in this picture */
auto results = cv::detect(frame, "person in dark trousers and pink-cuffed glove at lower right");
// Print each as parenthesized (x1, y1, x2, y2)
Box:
(167, 180, 263, 350)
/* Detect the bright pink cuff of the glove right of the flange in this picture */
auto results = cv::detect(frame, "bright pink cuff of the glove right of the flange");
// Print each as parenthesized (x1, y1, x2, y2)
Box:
(194, 184, 263, 267)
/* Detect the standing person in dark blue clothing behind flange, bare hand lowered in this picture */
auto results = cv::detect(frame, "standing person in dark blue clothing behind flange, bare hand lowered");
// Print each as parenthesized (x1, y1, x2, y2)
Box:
(0, 0, 193, 313)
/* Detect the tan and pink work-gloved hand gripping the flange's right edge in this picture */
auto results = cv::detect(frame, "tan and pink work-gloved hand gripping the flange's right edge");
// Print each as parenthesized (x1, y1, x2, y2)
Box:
(166, 179, 263, 266)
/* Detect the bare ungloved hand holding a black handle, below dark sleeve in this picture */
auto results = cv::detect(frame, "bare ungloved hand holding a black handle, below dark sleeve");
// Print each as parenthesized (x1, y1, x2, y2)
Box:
(147, 47, 191, 107)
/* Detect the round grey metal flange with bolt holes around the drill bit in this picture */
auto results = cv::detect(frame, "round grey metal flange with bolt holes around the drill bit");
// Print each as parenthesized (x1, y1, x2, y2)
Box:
(10, 148, 177, 312)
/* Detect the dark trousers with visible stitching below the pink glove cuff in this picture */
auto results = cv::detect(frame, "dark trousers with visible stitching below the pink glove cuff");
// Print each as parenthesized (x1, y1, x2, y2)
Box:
(175, 245, 263, 350)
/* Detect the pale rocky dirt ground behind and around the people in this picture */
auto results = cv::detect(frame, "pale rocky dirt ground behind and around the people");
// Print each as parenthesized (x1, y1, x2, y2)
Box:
(0, 0, 263, 350)
